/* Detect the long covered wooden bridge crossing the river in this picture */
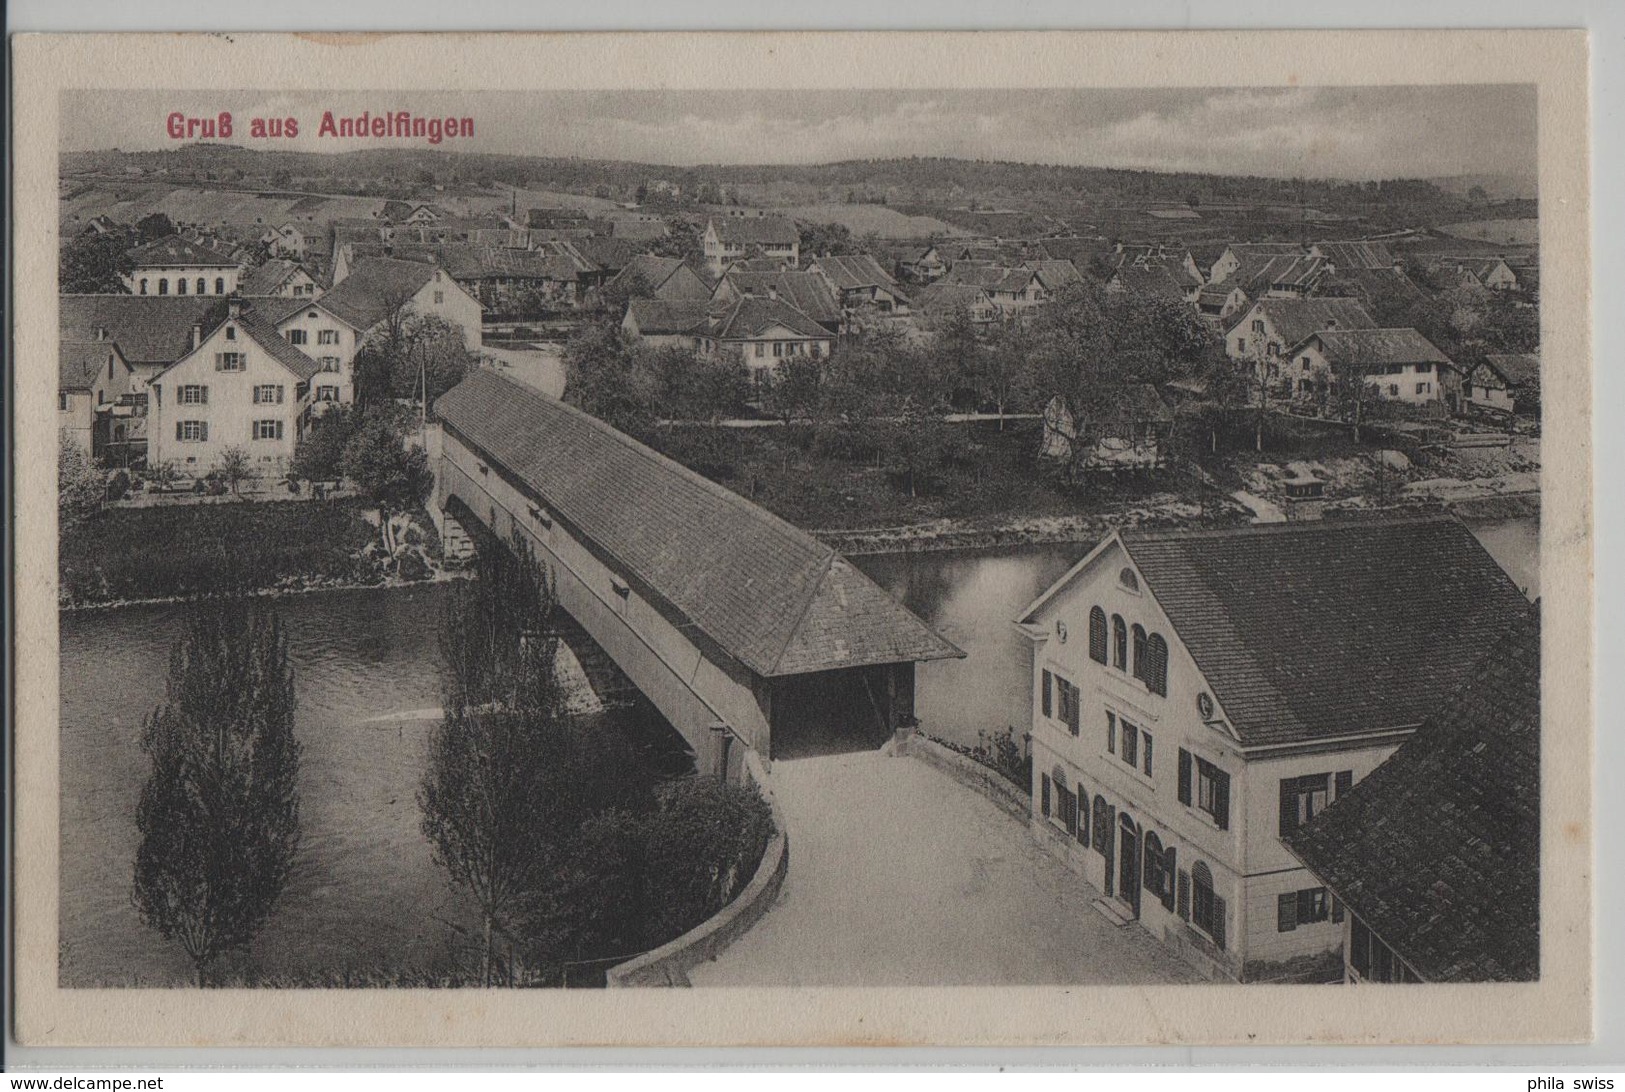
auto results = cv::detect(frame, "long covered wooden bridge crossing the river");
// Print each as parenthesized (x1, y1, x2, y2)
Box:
(429, 369, 964, 775)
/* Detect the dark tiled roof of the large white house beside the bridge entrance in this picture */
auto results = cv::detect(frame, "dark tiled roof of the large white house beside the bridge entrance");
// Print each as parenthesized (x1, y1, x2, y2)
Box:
(1123, 517, 1529, 746)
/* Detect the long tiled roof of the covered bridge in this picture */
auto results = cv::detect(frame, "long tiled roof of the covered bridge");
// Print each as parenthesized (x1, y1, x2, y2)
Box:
(436, 369, 964, 676)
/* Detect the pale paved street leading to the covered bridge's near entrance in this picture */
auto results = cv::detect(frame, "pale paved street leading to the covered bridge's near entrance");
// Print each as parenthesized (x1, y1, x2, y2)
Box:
(691, 752, 1199, 986)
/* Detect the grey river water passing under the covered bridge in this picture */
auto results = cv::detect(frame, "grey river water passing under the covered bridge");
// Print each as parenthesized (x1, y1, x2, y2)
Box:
(60, 518, 1539, 986)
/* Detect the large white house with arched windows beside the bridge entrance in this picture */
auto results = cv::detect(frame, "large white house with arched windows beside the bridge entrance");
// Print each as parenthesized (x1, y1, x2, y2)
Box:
(1016, 517, 1528, 982)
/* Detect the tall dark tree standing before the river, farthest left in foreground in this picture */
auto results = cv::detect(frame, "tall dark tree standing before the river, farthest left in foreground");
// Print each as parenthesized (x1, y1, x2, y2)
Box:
(133, 600, 299, 986)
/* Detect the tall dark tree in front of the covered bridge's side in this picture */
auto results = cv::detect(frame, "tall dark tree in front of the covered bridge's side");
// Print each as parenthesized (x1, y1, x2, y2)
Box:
(418, 536, 650, 985)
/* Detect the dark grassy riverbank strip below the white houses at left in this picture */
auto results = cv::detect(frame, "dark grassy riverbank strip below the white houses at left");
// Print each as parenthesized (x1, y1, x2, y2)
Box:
(57, 501, 377, 605)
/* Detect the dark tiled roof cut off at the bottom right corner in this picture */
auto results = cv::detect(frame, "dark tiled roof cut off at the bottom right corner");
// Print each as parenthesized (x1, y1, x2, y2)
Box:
(1285, 611, 1541, 982)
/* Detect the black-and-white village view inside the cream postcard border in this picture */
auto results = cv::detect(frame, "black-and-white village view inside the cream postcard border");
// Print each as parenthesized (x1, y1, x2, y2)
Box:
(6, 27, 1589, 1040)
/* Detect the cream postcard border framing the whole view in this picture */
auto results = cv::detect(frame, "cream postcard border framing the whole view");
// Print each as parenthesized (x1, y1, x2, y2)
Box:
(11, 31, 1593, 1047)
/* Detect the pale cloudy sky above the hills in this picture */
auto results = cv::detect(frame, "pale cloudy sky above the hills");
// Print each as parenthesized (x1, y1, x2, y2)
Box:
(62, 85, 1536, 179)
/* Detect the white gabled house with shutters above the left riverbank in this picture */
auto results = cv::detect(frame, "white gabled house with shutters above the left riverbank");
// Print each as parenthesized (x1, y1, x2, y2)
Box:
(146, 301, 320, 478)
